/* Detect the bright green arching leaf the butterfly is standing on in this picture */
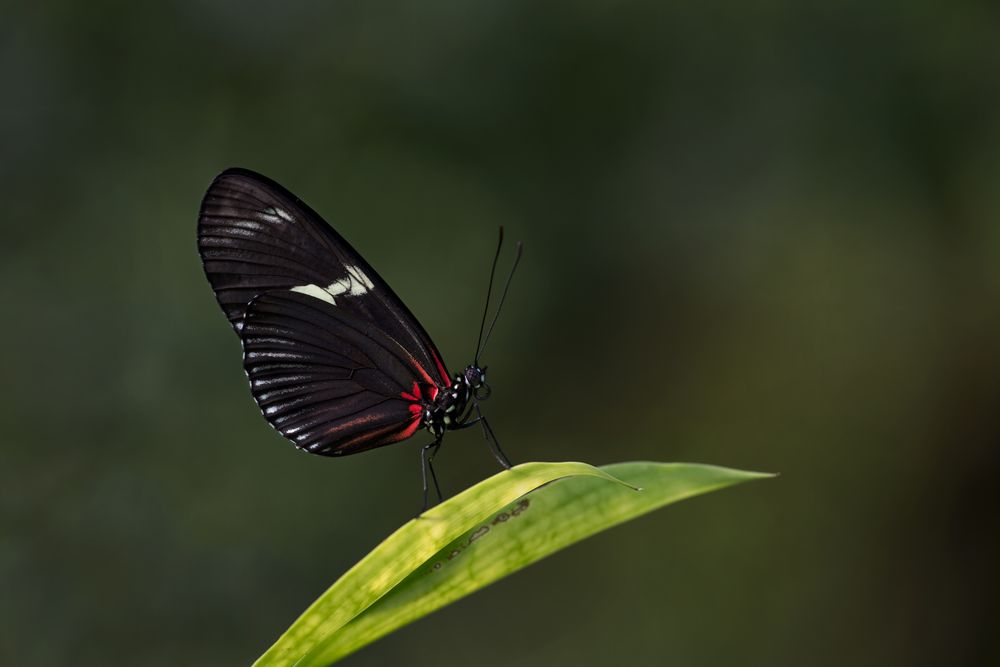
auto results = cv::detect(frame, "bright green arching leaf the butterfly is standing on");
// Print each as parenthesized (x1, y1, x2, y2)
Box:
(255, 462, 768, 667)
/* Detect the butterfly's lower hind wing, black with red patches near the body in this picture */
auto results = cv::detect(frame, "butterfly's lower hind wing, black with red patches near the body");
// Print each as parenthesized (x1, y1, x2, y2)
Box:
(241, 290, 437, 456)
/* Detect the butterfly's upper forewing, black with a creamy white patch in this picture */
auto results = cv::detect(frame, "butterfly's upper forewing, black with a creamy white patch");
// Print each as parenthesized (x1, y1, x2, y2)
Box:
(198, 169, 451, 387)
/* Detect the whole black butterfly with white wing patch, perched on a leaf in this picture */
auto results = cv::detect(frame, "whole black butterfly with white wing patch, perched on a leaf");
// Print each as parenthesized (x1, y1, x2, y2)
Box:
(198, 169, 521, 507)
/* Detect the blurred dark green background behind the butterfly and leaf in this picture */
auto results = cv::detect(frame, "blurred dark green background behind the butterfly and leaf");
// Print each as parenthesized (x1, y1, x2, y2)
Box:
(0, 0, 1000, 667)
